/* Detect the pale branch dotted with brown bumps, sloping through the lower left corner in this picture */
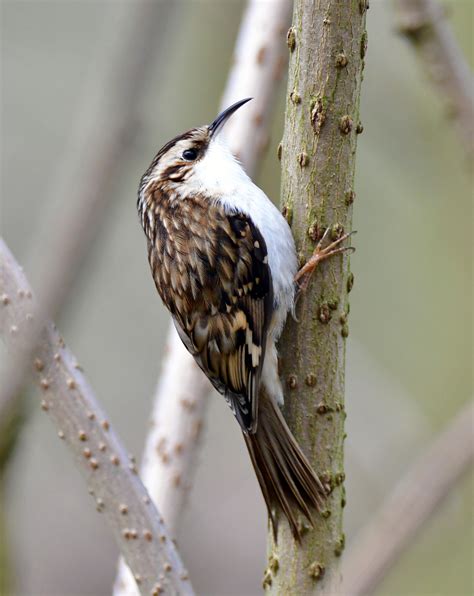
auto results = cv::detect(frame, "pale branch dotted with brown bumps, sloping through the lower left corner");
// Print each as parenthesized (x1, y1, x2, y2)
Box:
(0, 239, 193, 595)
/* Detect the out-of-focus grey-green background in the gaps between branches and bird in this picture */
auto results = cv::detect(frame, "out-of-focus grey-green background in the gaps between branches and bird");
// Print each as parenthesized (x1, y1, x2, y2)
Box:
(0, 0, 474, 596)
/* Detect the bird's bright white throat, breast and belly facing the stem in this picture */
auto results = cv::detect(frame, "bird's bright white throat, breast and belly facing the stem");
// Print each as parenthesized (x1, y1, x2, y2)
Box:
(187, 138, 297, 339)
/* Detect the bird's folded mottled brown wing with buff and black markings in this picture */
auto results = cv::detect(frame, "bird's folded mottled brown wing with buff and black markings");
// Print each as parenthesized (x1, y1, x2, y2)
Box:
(152, 204, 273, 433)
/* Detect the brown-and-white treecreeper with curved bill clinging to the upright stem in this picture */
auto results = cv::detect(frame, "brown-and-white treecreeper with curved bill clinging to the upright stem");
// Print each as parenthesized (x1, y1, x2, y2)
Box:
(137, 98, 351, 540)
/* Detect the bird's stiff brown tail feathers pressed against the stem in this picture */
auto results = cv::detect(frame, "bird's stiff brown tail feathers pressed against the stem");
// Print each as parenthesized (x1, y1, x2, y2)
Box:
(244, 389, 326, 541)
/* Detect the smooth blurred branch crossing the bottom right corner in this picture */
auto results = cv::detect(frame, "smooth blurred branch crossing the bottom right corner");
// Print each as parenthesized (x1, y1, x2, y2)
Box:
(342, 401, 474, 596)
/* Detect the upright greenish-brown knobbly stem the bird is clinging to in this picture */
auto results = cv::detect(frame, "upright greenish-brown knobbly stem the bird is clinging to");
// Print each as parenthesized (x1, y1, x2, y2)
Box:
(264, 0, 367, 594)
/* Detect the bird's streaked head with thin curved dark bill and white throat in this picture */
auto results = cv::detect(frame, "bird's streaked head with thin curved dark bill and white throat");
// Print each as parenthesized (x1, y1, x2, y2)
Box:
(139, 98, 251, 195)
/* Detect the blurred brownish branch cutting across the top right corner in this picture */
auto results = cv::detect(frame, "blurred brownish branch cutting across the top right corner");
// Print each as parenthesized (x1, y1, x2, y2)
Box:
(395, 0, 474, 165)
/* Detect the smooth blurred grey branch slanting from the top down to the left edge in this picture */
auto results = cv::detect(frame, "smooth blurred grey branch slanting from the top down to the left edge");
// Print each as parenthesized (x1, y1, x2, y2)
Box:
(0, 0, 172, 421)
